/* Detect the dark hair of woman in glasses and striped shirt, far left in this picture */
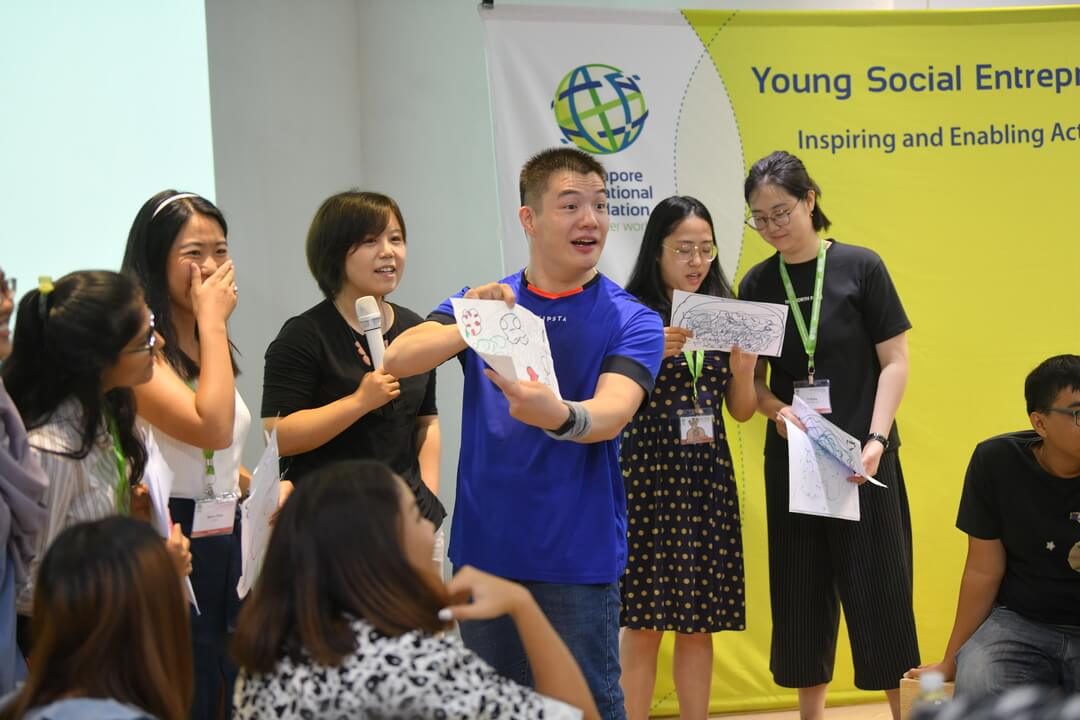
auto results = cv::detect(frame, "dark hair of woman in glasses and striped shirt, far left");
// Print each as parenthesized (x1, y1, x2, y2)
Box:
(3, 270, 147, 485)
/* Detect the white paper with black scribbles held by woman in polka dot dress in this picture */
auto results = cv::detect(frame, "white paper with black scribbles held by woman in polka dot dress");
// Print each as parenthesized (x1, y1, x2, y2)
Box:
(671, 290, 787, 357)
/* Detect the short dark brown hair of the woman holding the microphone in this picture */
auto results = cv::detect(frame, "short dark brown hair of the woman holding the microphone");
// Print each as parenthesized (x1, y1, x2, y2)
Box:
(306, 189, 406, 300)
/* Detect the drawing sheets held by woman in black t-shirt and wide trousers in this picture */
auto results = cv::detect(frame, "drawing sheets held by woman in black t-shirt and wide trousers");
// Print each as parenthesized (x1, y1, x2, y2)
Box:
(784, 397, 885, 520)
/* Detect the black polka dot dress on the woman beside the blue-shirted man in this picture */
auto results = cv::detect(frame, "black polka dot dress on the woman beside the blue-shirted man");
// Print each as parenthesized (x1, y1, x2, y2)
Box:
(620, 352, 746, 633)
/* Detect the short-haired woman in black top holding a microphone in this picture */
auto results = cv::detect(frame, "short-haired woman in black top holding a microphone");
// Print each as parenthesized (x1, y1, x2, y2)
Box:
(261, 191, 446, 535)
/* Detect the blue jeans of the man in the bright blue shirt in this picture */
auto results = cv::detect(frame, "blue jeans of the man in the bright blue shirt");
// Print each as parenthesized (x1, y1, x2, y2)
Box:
(461, 582, 626, 720)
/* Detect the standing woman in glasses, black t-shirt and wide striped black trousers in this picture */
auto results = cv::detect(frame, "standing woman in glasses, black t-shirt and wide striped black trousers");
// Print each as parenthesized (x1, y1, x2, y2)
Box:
(739, 151, 919, 718)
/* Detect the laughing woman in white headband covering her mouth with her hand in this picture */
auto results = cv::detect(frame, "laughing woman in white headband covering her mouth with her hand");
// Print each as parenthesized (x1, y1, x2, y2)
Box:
(123, 190, 261, 718)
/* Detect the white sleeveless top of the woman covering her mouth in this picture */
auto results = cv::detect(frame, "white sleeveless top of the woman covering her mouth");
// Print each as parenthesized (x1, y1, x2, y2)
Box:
(138, 391, 252, 499)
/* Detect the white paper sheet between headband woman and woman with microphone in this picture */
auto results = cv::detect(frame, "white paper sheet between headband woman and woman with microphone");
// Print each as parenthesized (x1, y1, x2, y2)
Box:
(237, 429, 281, 597)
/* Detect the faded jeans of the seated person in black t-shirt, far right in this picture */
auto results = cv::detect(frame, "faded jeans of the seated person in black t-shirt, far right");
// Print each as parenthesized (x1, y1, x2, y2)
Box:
(956, 607, 1080, 697)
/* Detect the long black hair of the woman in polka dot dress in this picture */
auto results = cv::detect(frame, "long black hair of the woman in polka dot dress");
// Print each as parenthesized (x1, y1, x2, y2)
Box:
(626, 195, 733, 322)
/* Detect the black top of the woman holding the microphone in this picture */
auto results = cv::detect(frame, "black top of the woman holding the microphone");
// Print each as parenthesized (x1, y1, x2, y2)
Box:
(262, 300, 446, 526)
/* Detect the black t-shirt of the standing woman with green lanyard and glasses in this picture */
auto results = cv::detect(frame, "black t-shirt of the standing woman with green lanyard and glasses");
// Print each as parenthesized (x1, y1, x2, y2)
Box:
(739, 240, 912, 457)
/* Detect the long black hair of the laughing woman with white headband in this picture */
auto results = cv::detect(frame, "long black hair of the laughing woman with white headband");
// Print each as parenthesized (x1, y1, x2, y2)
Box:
(120, 190, 239, 380)
